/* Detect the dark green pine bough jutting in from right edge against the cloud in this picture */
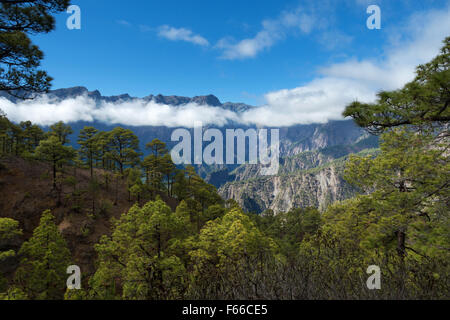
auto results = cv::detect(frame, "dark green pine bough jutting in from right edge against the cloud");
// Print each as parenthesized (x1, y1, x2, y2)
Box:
(344, 37, 450, 134)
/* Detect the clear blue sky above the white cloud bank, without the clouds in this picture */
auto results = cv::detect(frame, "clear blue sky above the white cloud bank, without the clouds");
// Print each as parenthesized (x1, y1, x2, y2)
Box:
(35, 0, 447, 104)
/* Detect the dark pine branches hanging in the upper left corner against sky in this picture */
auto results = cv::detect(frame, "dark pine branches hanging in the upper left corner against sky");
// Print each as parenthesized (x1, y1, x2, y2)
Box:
(0, 0, 69, 98)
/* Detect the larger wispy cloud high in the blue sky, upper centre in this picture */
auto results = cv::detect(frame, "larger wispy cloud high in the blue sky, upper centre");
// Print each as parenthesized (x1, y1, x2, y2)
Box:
(216, 8, 316, 60)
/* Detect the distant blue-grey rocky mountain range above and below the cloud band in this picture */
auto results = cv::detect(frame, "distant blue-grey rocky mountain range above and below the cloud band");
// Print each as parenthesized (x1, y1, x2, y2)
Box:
(0, 87, 378, 212)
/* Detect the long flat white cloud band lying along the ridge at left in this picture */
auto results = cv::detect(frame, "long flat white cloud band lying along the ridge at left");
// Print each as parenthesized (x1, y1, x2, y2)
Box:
(0, 96, 239, 127)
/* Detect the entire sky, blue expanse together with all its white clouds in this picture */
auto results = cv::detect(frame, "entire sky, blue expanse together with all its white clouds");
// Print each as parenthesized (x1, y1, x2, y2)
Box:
(2, 0, 450, 127)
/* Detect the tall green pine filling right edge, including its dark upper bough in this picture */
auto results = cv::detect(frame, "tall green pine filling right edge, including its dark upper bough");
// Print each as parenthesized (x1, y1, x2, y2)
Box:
(324, 38, 450, 298)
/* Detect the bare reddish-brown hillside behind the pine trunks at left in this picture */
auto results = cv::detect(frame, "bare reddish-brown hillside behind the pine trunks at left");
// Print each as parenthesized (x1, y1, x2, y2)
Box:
(0, 156, 178, 274)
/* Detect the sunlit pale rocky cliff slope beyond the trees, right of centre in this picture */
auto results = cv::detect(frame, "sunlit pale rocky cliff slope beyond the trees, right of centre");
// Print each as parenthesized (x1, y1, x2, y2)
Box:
(219, 142, 377, 213)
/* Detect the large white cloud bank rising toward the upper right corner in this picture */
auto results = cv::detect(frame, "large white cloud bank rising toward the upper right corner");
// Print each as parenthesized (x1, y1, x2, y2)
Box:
(237, 9, 450, 126)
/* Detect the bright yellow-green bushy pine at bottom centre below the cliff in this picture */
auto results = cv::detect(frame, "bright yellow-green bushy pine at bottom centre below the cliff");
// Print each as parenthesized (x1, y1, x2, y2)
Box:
(189, 209, 277, 299)
